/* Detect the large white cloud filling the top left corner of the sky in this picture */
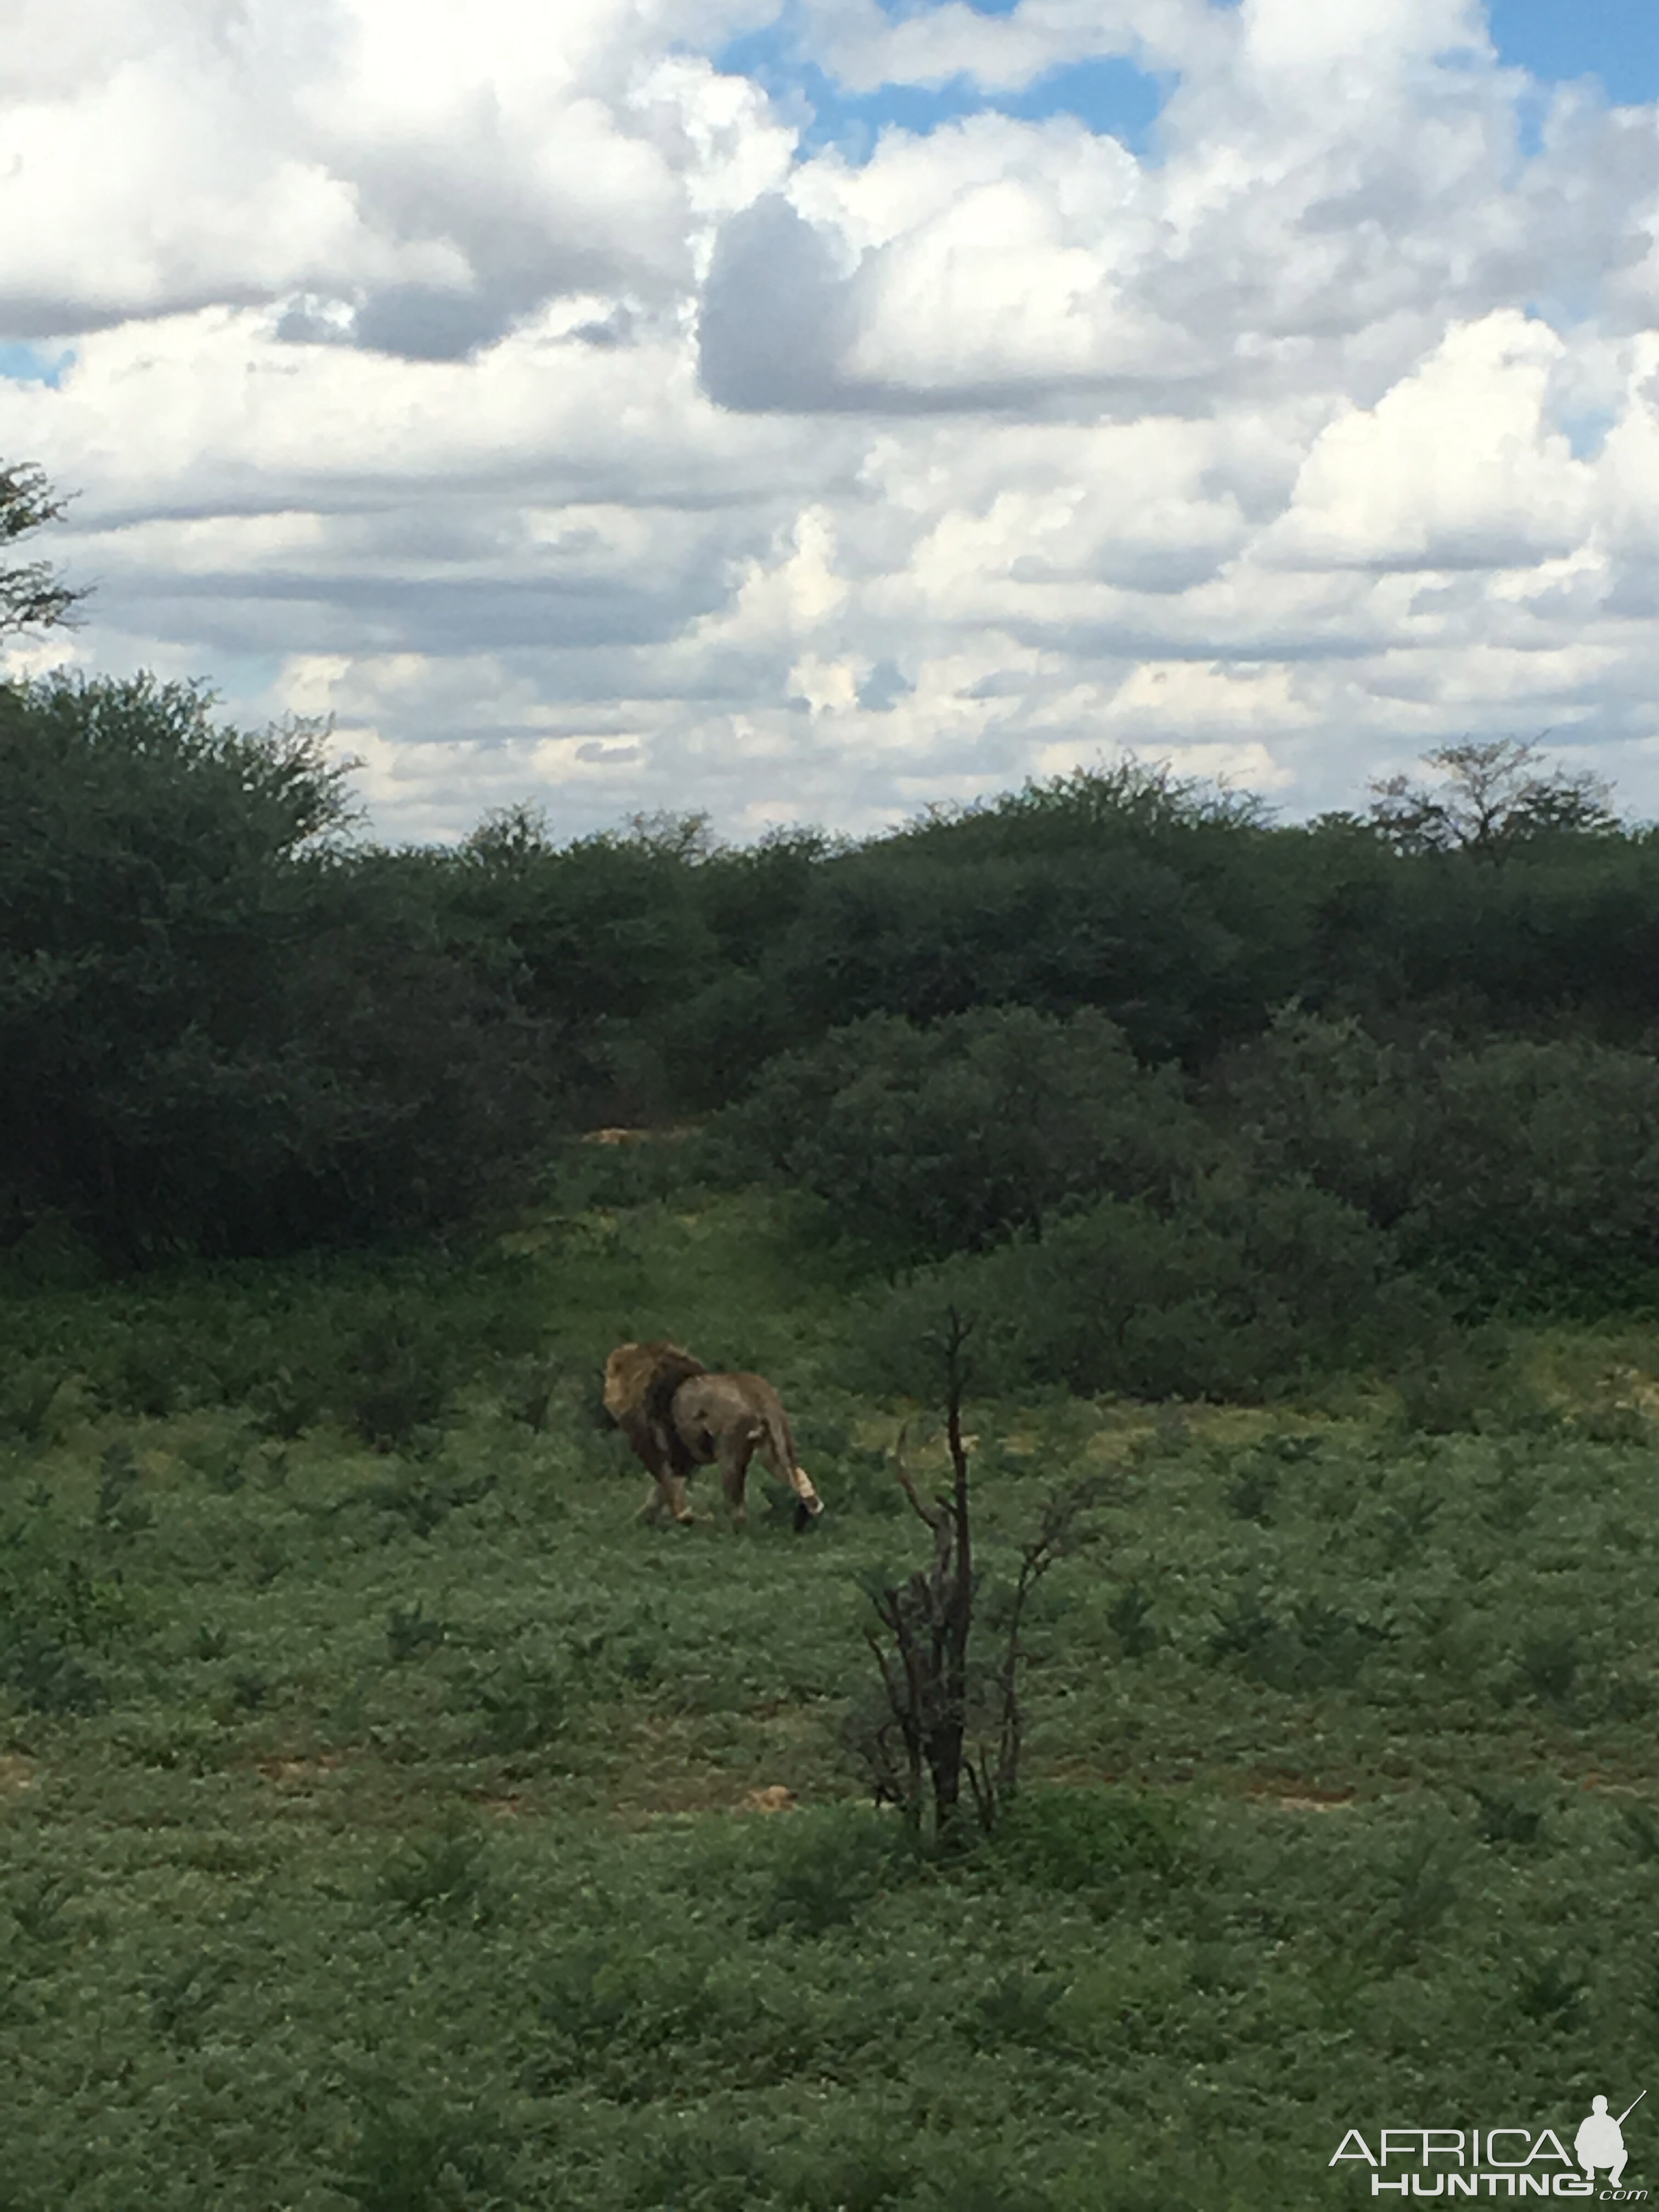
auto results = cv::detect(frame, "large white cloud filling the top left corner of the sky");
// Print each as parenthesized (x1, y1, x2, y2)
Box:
(0, 0, 789, 340)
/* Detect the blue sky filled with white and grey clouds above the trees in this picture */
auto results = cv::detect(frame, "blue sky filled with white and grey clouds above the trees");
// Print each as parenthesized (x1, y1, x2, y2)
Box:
(0, 0, 1659, 838)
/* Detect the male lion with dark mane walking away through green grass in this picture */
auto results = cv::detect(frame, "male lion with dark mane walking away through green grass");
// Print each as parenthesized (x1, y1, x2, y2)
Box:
(604, 1345, 823, 1528)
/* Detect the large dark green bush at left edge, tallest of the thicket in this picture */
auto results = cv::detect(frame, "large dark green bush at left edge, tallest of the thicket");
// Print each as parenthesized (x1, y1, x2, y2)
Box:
(0, 677, 566, 1261)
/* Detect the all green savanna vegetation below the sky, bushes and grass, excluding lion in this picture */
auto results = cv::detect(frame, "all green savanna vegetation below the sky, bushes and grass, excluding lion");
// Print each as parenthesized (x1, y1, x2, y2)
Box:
(0, 458, 1659, 2212)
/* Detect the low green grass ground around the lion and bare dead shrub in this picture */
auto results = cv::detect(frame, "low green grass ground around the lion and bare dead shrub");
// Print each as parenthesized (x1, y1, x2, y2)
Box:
(0, 1201, 1659, 2212)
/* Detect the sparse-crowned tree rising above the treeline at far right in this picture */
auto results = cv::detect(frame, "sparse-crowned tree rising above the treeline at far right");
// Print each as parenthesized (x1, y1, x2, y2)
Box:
(1372, 737, 1619, 860)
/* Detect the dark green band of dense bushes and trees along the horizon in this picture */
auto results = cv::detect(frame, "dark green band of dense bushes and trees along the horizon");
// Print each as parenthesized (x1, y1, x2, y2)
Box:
(0, 677, 1659, 1327)
